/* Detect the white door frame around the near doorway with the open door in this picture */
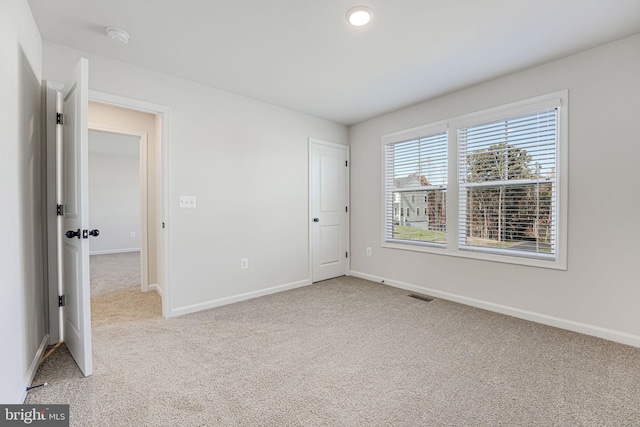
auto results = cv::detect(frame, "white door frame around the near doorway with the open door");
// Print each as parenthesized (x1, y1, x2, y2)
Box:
(44, 81, 172, 344)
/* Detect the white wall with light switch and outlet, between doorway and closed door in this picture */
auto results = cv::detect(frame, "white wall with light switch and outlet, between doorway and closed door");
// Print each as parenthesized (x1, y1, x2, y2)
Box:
(43, 42, 348, 315)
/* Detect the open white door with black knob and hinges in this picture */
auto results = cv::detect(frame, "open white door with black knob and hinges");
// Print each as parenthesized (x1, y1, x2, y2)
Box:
(58, 58, 96, 376)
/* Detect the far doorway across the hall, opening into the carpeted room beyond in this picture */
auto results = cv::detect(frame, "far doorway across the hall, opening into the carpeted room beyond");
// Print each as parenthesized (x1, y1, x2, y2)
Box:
(88, 126, 149, 298)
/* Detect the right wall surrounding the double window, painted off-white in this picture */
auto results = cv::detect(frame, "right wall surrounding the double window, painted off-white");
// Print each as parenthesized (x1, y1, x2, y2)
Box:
(350, 35, 640, 346)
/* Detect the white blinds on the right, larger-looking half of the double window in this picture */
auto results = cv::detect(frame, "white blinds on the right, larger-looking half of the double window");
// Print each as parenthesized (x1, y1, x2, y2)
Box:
(458, 108, 558, 258)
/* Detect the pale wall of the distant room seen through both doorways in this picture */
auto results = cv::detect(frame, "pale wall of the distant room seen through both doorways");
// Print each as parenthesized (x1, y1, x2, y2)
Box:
(89, 131, 140, 255)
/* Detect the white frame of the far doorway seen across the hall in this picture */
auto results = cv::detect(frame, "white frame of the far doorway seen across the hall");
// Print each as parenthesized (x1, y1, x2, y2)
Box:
(89, 123, 149, 292)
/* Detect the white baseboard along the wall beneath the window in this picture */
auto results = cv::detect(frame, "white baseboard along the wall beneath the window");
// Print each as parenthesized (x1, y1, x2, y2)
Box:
(351, 270, 640, 348)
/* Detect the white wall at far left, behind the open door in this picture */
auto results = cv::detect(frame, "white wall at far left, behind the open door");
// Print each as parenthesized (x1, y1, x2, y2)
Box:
(0, 0, 47, 403)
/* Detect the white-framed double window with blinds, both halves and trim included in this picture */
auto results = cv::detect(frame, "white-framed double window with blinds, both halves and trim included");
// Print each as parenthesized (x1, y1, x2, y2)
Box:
(383, 91, 567, 269)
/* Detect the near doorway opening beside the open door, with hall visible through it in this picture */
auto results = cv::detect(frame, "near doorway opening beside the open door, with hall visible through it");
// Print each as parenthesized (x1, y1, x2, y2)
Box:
(81, 99, 166, 327)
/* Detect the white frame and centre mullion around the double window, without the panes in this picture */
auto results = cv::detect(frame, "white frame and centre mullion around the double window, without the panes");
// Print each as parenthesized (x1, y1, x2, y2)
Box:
(381, 90, 569, 270)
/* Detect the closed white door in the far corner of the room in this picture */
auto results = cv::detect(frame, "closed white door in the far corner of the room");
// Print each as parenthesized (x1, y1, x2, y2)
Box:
(309, 140, 349, 282)
